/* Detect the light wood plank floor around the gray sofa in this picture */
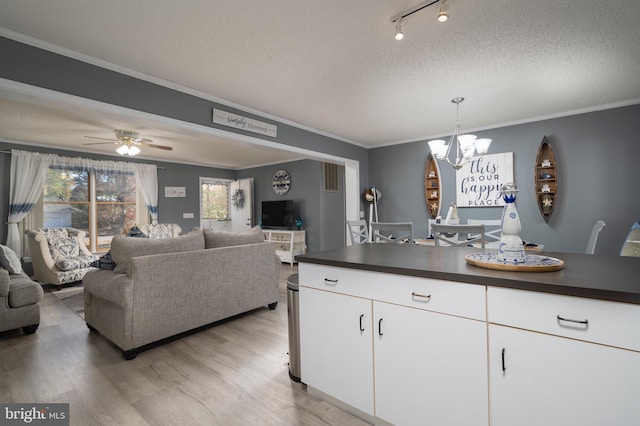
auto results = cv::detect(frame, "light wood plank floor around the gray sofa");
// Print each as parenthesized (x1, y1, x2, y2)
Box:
(0, 264, 366, 426)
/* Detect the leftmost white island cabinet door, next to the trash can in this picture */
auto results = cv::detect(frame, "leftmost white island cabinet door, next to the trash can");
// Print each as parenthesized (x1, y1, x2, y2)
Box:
(299, 287, 373, 415)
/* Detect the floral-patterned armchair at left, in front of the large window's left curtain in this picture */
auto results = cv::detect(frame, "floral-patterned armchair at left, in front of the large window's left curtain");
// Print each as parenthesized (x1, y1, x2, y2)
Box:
(25, 228, 98, 289)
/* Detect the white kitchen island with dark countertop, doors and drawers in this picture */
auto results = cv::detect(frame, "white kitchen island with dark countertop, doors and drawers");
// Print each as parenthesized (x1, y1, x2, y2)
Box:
(296, 244, 640, 425)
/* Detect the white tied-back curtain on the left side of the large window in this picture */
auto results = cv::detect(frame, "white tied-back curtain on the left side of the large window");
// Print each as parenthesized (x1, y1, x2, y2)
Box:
(7, 149, 55, 255)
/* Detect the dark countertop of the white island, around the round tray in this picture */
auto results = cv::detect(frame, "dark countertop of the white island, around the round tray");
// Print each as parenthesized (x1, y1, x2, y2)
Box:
(296, 244, 640, 304)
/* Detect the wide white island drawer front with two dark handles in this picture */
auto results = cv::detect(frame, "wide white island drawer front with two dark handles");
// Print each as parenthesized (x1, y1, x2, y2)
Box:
(299, 263, 486, 321)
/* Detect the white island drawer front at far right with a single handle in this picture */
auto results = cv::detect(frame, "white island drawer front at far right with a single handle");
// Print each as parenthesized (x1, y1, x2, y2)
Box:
(487, 287, 640, 351)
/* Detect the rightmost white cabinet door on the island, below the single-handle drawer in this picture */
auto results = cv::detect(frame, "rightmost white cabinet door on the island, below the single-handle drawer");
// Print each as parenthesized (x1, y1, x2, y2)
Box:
(489, 324, 640, 426)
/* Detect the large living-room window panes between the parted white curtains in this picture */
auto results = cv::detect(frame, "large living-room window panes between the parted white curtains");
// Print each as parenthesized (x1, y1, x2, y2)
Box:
(43, 167, 138, 252)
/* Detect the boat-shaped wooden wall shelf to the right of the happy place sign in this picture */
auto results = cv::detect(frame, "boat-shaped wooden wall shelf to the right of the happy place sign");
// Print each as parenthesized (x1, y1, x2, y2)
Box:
(534, 136, 558, 220)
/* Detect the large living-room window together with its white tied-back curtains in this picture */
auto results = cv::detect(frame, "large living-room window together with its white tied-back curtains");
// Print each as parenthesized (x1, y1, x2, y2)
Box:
(7, 150, 158, 255)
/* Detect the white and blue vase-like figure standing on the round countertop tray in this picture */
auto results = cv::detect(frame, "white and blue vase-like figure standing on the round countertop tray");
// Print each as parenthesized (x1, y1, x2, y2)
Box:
(498, 183, 525, 263)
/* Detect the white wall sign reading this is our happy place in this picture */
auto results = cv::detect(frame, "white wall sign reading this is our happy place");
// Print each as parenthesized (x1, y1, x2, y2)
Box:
(456, 152, 513, 207)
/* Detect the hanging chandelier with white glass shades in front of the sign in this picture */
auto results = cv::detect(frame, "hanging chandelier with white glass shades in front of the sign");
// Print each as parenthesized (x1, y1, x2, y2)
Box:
(428, 98, 491, 170)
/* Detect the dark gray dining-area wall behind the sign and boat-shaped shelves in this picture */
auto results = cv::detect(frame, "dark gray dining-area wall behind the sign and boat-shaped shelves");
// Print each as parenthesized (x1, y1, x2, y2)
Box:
(369, 105, 640, 255)
